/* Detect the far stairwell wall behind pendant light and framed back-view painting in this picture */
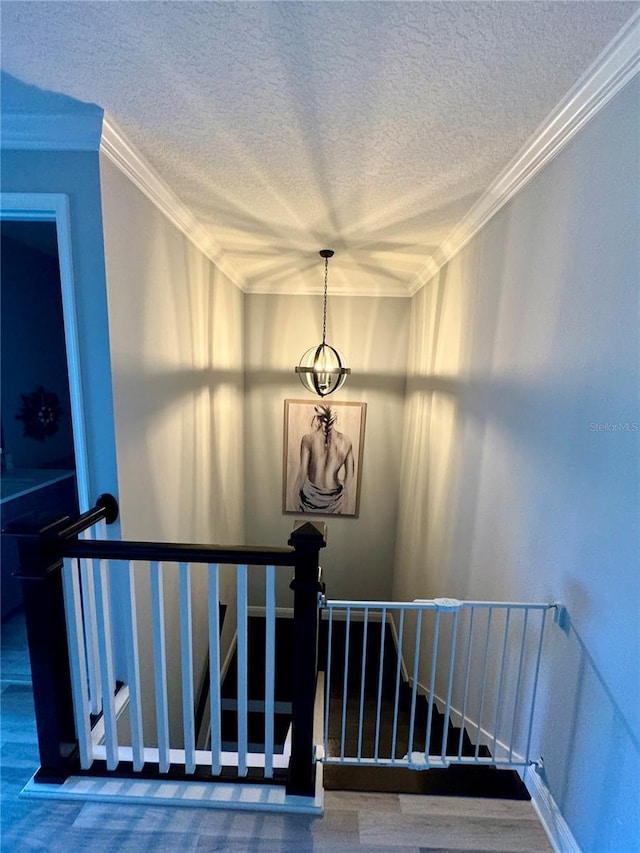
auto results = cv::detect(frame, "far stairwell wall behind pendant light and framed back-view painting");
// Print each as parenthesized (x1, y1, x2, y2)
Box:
(245, 296, 410, 606)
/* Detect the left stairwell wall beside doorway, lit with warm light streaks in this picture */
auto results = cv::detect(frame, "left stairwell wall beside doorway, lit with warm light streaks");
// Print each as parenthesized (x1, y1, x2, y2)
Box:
(101, 157, 244, 742)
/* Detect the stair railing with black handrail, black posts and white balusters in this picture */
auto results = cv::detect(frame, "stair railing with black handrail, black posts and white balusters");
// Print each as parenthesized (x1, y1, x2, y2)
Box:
(17, 495, 326, 796)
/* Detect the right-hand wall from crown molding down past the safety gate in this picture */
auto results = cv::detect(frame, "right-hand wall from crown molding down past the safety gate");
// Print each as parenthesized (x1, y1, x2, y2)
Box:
(394, 76, 640, 851)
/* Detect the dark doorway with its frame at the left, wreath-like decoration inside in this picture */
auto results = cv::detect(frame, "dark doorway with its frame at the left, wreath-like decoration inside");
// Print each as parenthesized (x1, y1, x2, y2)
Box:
(0, 194, 88, 620)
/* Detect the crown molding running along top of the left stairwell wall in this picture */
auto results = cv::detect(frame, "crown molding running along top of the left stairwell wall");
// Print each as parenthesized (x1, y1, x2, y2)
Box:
(100, 113, 246, 291)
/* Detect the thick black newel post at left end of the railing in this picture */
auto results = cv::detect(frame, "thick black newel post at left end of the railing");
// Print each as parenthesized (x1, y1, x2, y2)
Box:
(16, 517, 79, 783)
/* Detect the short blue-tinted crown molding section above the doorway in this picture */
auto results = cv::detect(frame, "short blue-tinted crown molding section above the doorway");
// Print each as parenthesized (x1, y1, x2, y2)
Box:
(0, 109, 102, 151)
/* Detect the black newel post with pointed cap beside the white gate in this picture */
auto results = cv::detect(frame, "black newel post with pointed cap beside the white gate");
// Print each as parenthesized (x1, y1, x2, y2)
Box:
(287, 522, 327, 797)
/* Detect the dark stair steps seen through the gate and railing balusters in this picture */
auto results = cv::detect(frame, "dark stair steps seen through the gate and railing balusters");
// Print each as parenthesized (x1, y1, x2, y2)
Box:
(222, 616, 530, 800)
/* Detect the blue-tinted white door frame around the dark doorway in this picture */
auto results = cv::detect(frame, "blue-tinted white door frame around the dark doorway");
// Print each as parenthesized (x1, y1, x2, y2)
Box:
(0, 193, 90, 512)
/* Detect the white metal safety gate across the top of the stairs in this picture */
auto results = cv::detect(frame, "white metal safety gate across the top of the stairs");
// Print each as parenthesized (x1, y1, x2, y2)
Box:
(323, 598, 556, 770)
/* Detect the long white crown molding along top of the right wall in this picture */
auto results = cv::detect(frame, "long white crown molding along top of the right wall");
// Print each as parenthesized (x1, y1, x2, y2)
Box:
(409, 11, 640, 296)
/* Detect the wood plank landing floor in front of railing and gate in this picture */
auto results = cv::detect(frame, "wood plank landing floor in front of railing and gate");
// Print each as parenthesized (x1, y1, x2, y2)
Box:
(0, 618, 552, 853)
